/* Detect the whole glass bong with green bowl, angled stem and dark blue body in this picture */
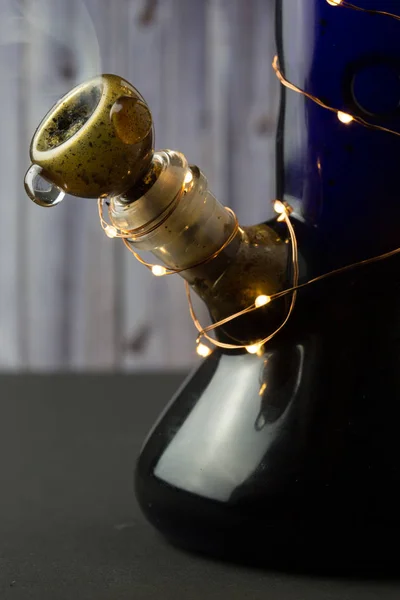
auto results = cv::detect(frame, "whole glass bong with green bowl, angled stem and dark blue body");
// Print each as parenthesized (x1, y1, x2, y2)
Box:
(26, 0, 400, 568)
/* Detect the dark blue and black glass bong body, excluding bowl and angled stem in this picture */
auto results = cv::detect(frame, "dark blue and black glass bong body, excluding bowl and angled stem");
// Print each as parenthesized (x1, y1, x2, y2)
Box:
(135, 0, 400, 570)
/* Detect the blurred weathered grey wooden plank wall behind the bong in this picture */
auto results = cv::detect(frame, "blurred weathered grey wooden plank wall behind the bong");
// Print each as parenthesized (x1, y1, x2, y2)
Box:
(0, 0, 279, 371)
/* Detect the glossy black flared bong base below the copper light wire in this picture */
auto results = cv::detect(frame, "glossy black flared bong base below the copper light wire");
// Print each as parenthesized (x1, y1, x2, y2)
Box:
(135, 258, 400, 571)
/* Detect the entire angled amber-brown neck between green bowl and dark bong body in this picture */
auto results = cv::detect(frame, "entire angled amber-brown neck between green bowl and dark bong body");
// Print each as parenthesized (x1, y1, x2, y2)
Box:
(109, 150, 289, 345)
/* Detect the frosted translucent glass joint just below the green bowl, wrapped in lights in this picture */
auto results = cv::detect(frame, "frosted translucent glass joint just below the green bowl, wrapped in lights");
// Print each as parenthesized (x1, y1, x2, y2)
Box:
(110, 150, 244, 283)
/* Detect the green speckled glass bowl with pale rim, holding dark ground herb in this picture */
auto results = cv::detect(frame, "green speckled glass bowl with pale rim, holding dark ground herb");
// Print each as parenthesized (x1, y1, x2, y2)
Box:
(30, 75, 154, 198)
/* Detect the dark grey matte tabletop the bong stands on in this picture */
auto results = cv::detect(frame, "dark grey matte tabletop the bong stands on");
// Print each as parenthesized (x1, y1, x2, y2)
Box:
(0, 374, 400, 600)
